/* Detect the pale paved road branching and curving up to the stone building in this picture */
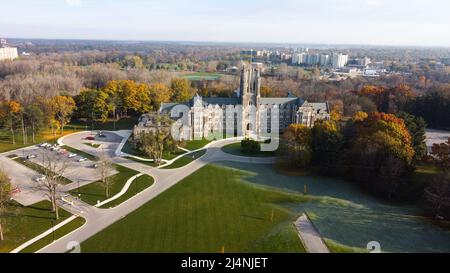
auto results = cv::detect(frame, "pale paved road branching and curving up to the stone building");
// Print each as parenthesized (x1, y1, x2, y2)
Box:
(39, 132, 275, 253)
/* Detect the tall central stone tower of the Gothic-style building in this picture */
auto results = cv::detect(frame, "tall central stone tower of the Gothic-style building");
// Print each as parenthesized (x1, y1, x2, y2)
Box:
(240, 63, 262, 137)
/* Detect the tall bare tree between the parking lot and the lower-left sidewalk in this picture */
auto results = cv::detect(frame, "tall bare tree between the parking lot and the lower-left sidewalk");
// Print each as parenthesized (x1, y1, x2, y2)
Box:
(39, 150, 69, 220)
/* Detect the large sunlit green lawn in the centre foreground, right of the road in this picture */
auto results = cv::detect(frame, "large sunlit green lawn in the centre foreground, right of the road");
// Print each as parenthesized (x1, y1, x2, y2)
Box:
(82, 165, 305, 253)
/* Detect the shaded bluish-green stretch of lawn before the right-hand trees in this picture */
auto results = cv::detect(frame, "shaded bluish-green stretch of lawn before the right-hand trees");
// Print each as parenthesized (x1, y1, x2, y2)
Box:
(214, 162, 450, 253)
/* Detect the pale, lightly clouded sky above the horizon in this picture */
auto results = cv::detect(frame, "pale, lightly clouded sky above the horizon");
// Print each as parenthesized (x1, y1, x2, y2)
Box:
(0, 0, 450, 47)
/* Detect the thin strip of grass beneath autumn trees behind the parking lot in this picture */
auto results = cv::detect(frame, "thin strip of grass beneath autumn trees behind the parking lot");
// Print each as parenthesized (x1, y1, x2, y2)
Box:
(68, 117, 139, 131)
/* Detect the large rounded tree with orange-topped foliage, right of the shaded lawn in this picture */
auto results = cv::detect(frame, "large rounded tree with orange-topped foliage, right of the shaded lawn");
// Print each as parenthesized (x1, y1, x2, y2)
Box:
(348, 113, 415, 199)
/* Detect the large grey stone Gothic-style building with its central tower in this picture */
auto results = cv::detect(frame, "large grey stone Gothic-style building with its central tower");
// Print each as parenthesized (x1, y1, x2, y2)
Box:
(134, 63, 330, 140)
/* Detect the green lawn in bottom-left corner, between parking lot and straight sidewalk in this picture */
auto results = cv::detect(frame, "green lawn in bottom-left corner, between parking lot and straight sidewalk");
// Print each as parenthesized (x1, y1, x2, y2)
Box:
(0, 201, 71, 253)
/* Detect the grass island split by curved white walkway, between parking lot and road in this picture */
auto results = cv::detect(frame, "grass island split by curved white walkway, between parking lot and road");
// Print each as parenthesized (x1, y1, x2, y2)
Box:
(70, 165, 153, 207)
